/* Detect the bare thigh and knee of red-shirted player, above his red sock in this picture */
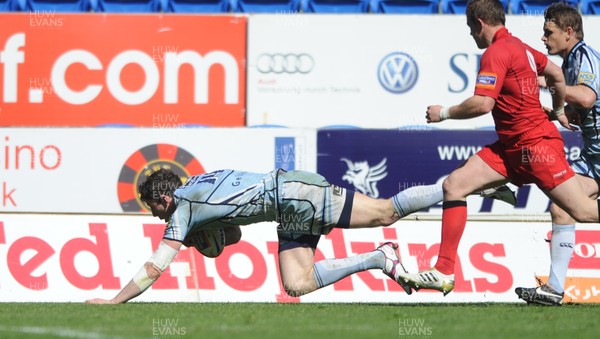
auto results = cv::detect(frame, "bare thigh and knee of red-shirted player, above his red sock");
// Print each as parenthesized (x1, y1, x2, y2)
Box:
(444, 154, 507, 200)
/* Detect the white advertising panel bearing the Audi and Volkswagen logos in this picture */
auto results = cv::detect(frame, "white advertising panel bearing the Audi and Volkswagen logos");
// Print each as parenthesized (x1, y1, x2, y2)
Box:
(247, 14, 600, 129)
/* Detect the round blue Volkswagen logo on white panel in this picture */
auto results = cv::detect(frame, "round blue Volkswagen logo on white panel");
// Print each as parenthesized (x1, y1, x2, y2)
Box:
(377, 52, 419, 94)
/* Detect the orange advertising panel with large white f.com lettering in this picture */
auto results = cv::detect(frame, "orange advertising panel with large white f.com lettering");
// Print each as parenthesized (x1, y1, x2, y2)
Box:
(0, 12, 247, 127)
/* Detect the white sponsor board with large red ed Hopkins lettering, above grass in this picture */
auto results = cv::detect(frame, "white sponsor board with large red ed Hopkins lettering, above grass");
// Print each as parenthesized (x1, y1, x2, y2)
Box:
(0, 214, 600, 303)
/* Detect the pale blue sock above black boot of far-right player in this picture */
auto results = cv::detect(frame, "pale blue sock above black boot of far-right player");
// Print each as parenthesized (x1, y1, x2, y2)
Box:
(548, 224, 575, 293)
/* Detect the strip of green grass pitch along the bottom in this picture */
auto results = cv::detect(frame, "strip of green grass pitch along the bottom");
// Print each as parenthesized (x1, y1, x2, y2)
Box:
(0, 303, 600, 339)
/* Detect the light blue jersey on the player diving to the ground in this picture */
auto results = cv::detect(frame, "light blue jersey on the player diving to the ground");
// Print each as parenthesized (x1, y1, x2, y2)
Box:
(164, 170, 276, 241)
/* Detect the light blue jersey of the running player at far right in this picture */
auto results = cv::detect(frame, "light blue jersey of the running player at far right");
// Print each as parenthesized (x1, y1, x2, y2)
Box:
(562, 40, 600, 155)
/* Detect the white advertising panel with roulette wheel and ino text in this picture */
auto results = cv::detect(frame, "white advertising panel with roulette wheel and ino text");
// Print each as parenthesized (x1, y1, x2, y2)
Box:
(0, 127, 316, 213)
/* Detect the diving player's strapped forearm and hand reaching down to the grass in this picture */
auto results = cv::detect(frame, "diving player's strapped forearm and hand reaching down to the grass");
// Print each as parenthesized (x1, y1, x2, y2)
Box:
(86, 239, 181, 304)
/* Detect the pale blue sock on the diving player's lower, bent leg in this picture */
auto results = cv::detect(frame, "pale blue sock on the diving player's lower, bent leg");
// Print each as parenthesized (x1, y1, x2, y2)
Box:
(313, 251, 385, 288)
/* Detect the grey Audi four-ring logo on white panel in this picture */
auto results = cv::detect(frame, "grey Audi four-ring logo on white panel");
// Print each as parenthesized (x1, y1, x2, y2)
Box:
(256, 53, 315, 74)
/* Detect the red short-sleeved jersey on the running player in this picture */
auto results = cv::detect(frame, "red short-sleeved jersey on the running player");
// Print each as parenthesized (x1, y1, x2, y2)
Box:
(475, 27, 548, 144)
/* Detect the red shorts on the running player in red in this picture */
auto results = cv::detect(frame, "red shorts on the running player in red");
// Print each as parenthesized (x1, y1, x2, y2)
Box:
(477, 126, 575, 191)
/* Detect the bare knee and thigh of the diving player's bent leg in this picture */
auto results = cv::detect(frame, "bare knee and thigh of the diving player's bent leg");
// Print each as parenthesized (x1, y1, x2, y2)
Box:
(279, 247, 315, 286)
